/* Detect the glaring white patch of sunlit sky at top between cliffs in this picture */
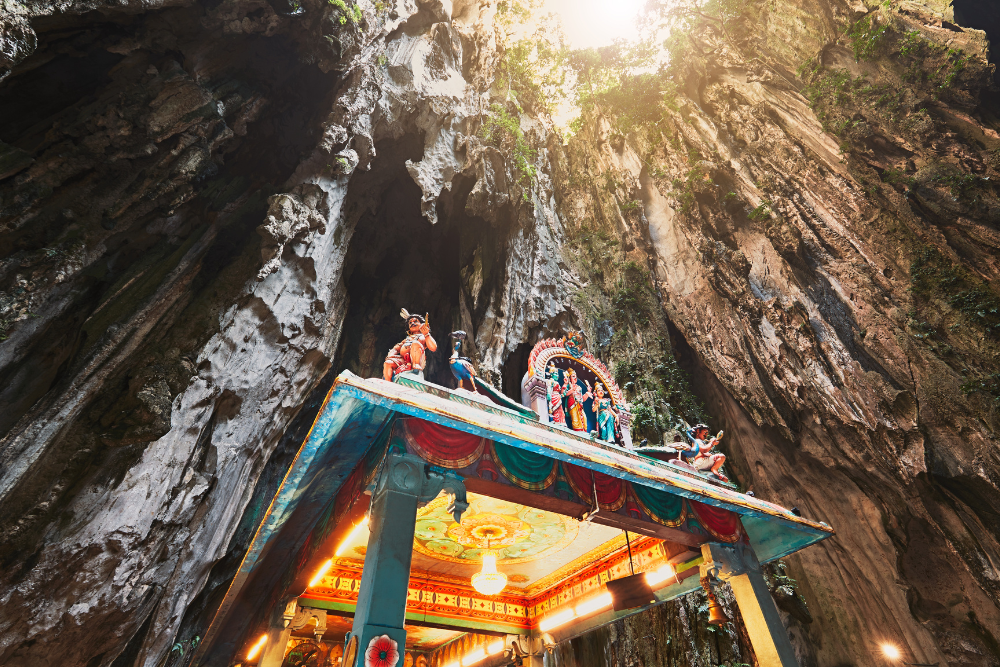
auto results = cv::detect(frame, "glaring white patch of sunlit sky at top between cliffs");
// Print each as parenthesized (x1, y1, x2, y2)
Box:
(541, 0, 645, 49)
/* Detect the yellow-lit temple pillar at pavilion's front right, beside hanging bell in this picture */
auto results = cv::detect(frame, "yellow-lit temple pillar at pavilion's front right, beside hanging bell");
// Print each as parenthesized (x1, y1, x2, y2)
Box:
(701, 542, 799, 667)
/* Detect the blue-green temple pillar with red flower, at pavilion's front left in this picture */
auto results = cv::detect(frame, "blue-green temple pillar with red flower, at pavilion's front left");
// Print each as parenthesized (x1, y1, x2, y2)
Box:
(344, 454, 469, 667)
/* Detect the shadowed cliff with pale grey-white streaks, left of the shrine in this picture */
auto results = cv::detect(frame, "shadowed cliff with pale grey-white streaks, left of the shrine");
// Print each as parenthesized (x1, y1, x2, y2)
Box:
(0, 2, 570, 665)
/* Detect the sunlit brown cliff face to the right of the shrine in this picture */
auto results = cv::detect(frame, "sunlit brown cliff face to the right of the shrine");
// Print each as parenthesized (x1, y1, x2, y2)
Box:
(557, 3, 1000, 665)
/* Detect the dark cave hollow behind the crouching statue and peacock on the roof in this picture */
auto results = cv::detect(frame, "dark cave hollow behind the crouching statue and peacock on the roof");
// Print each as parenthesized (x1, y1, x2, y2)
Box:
(332, 142, 520, 399)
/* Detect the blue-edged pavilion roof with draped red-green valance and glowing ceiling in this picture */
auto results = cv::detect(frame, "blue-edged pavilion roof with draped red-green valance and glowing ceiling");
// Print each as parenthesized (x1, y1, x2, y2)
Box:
(193, 354, 833, 667)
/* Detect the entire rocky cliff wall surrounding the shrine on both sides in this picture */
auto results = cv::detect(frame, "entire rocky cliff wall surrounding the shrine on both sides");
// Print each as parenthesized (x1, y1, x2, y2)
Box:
(0, 0, 1000, 667)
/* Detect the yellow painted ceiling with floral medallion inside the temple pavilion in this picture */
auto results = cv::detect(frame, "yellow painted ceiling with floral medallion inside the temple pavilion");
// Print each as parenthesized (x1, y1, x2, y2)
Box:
(332, 493, 625, 589)
